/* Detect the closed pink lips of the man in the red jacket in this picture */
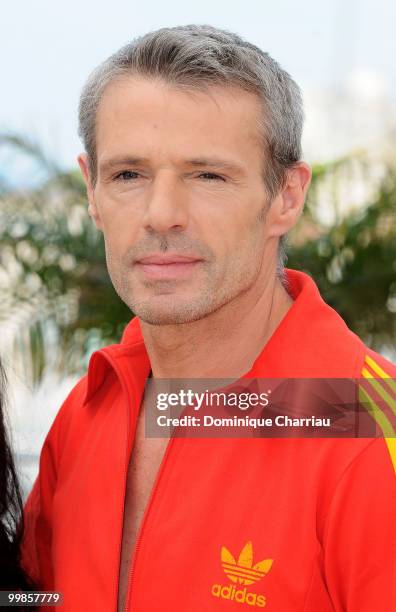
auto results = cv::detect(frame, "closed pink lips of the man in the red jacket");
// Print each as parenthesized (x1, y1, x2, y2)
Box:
(135, 255, 203, 280)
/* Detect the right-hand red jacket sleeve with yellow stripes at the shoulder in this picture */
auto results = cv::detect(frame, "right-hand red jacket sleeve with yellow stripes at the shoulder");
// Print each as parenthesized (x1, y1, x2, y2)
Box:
(324, 348, 396, 612)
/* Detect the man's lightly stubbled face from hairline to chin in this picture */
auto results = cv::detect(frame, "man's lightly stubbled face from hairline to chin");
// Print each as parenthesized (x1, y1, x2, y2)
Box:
(84, 77, 276, 325)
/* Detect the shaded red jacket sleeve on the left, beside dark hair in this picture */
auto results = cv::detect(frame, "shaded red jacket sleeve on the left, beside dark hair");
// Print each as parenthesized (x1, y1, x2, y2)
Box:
(21, 378, 86, 590)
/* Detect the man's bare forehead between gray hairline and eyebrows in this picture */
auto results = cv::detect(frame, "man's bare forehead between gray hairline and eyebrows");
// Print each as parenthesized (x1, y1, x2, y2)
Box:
(96, 77, 262, 171)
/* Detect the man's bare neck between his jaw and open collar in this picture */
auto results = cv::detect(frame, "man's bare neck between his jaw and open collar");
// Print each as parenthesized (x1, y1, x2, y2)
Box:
(141, 274, 293, 378)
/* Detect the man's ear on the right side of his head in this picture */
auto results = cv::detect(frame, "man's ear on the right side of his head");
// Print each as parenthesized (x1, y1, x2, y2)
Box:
(268, 162, 312, 236)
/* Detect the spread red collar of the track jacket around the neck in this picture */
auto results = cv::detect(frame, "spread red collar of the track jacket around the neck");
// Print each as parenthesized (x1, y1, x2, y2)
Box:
(85, 268, 364, 402)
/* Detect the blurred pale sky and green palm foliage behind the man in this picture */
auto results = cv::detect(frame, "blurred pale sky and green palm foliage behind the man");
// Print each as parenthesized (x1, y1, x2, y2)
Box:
(0, 0, 396, 494)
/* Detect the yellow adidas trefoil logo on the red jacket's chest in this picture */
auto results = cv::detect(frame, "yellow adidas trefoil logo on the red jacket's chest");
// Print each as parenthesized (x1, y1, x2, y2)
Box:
(212, 541, 273, 608)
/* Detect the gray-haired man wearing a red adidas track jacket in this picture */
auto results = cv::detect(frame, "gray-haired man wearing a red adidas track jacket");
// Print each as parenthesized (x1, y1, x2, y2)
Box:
(24, 26, 396, 612)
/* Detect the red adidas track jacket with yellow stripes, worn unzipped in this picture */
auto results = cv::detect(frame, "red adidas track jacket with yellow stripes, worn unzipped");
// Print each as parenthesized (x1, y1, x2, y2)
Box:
(23, 270, 396, 612)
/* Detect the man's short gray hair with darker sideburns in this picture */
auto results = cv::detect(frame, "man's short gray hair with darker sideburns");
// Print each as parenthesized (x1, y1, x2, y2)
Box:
(79, 25, 304, 273)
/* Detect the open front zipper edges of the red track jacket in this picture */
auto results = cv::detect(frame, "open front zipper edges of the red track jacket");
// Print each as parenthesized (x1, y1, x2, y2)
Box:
(98, 350, 174, 612)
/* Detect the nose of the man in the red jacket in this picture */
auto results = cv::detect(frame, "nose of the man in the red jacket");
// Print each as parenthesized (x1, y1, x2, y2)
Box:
(144, 170, 188, 233)
